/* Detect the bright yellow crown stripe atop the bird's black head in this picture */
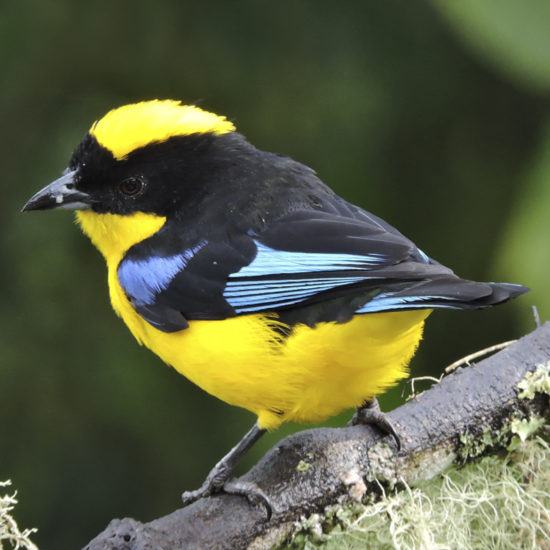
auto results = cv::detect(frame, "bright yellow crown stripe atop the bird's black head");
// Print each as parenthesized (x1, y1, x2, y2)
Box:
(90, 99, 235, 160)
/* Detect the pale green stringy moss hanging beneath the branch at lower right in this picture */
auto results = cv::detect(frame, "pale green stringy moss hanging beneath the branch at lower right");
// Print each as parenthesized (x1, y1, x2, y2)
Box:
(283, 437, 550, 550)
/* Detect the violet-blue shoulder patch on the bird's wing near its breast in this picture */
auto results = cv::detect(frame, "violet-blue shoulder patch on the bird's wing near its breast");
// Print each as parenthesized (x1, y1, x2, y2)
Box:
(118, 241, 206, 306)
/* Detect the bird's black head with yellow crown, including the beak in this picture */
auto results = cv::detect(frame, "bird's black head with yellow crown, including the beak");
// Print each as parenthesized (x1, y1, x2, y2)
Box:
(23, 101, 246, 216)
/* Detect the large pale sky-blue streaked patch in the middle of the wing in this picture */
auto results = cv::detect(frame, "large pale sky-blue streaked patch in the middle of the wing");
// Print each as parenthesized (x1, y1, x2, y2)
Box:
(223, 240, 387, 313)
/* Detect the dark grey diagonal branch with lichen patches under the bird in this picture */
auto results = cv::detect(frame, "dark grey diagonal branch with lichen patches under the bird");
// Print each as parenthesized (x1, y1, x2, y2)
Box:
(86, 323, 550, 550)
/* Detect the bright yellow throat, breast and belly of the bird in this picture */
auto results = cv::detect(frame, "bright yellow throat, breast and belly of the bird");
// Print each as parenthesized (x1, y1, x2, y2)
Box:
(77, 211, 431, 429)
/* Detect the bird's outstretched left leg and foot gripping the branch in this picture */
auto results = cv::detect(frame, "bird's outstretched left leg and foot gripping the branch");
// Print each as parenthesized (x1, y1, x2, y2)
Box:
(181, 424, 272, 519)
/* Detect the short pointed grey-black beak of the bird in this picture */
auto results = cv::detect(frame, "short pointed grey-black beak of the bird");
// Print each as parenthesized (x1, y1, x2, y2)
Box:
(21, 170, 90, 212)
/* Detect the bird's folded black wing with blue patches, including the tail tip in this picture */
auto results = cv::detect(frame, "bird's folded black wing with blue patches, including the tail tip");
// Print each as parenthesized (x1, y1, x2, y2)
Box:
(118, 210, 527, 332)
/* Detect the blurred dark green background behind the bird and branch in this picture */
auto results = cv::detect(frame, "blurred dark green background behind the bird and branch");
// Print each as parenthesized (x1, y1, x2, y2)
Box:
(0, 0, 550, 549)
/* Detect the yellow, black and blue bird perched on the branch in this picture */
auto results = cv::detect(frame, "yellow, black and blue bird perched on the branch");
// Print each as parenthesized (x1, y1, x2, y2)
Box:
(23, 99, 528, 514)
